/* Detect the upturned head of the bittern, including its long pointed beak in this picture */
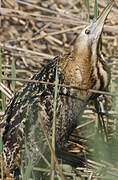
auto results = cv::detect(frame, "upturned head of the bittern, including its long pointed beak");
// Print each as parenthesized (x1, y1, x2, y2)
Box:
(75, 1, 114, 55)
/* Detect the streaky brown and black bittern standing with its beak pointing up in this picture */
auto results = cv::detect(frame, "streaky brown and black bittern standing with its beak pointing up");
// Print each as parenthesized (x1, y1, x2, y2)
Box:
(1, 1, 113, 179)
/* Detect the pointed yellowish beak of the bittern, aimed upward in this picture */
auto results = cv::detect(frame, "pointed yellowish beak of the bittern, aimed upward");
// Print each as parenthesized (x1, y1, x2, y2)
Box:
(90, 1, 114, 40)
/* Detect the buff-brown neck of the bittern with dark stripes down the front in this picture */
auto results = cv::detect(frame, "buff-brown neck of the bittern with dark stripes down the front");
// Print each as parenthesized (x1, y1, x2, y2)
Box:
(60, 44, 109, 90)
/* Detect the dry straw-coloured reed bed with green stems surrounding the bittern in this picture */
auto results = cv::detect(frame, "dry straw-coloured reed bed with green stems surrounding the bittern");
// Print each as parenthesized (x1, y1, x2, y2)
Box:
(0, 0, 118, 180)
